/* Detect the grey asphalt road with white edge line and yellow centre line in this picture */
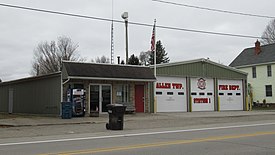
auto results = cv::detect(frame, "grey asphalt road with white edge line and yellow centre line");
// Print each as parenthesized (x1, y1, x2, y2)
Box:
(0, 121, 275, 155)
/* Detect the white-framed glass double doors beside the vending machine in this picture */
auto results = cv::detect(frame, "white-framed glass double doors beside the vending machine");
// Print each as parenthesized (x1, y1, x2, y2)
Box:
(90, 84, 112, 113)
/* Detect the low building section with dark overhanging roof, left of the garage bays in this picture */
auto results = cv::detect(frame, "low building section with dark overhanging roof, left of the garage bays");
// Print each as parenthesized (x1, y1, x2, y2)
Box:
(0, 62, 155, 116)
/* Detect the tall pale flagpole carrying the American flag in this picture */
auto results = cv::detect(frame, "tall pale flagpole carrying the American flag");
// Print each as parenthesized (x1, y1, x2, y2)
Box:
(154, 19, 157, 113)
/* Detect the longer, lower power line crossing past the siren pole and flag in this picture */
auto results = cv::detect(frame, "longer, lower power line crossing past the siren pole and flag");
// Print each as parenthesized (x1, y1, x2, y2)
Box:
(0, 3, 268, 39)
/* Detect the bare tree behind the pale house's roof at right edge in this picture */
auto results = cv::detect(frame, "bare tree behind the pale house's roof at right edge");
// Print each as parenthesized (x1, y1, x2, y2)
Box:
(261, 19, 275, 45)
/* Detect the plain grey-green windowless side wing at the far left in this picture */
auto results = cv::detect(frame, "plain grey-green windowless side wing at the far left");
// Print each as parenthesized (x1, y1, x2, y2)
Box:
(0, 72, 62, 115)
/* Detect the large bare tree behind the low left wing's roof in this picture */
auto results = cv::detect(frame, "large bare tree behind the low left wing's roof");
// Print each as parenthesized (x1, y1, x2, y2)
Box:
(31, 36, 85, 75)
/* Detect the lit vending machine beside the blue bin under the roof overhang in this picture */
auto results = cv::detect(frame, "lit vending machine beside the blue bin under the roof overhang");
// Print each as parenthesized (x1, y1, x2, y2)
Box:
(67, 89, 86, 116)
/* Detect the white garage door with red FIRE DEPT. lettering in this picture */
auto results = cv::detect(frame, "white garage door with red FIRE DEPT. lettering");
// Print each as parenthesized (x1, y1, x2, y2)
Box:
(218, 80, 244, 111)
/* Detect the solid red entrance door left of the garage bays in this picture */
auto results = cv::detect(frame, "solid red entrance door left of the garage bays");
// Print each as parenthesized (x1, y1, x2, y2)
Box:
(135, 85, 144, 112)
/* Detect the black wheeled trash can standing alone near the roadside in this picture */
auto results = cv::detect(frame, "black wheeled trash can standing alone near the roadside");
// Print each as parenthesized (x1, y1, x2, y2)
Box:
(106, 104, 126, 130)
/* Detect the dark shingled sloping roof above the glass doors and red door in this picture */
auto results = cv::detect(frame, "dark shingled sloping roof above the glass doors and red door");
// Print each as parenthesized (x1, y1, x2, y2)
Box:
(63, 61, 156, 81)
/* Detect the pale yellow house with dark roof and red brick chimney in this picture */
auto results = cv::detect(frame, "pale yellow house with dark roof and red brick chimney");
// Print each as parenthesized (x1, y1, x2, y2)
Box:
(229, 41, 275, 103)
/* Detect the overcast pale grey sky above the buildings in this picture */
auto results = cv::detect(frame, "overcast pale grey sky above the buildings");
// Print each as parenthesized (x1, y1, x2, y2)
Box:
(0, 0, 275, 81)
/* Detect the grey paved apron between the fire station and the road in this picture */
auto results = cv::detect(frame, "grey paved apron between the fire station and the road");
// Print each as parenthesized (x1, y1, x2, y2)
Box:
(0, 111, 275, 139)
